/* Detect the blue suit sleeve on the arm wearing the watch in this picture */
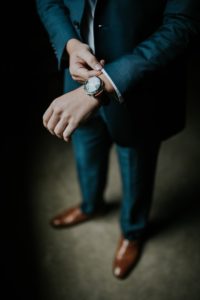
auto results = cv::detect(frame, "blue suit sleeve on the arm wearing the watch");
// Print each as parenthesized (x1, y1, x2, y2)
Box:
(104, 0, 200, 96)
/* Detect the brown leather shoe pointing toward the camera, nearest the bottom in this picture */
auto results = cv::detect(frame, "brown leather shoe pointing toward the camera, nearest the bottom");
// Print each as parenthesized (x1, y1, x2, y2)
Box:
(113, 236, 141, 279)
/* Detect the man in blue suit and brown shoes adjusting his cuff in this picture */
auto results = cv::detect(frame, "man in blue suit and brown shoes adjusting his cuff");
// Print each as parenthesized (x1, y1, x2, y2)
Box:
(37, 0, 200, 279)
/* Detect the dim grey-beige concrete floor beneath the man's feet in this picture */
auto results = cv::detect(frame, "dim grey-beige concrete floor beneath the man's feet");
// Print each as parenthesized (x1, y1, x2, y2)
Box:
(27, 78, 200, 300)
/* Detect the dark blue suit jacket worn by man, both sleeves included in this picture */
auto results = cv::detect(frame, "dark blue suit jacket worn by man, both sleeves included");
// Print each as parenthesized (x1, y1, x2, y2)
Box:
(37, 0, 200, 146)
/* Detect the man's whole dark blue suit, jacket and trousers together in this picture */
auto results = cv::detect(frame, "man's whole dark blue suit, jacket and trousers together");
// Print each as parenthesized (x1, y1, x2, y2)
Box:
(37, 0, 200, 238)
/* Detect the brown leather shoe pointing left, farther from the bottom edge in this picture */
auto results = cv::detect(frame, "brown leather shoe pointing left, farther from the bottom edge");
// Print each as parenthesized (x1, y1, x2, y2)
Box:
(50, 206, 92, 228)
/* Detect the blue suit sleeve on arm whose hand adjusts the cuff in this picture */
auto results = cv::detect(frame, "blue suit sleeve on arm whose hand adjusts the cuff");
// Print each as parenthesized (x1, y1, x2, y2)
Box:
(36, 0, 78, 69)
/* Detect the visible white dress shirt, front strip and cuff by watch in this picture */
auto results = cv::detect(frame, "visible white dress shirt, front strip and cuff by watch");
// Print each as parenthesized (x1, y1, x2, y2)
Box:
(83, 0, 124, 103)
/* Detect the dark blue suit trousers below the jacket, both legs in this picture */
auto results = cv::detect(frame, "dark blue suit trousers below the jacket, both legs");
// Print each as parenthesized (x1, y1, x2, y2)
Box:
(72, 108, 160, 240)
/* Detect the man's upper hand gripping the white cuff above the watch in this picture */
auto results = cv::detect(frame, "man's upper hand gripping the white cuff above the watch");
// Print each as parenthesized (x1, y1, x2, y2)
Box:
(66, 39, 104, 83)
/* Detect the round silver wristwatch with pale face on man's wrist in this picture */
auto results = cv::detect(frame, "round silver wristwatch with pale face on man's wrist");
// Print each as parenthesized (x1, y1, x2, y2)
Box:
(83, 76, 104, 97)
